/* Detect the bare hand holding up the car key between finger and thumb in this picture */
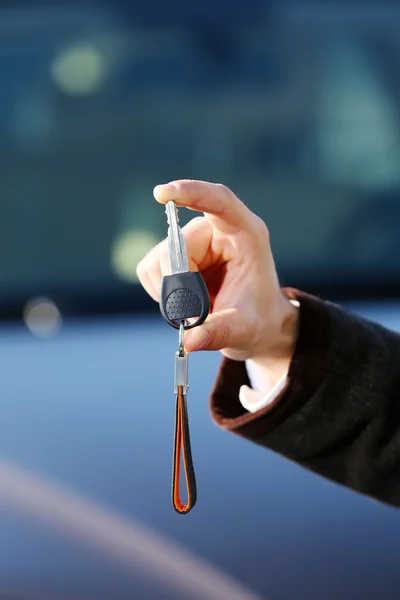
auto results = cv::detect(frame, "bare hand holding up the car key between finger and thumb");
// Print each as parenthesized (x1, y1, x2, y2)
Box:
(137, 180, 298, 379)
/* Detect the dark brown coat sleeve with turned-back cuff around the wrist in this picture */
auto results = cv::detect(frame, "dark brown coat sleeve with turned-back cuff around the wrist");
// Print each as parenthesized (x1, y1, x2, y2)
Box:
(210, 289, 400, 506)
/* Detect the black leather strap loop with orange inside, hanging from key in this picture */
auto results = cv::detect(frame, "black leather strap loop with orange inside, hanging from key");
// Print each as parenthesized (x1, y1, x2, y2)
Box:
(172, 386, 197, 515)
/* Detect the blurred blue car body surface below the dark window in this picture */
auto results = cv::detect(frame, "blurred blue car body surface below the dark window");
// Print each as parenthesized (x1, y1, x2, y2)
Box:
(0, 303, 400, 600)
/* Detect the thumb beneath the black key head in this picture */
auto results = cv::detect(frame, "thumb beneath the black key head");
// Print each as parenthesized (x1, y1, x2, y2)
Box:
(185, 308, 240, 352)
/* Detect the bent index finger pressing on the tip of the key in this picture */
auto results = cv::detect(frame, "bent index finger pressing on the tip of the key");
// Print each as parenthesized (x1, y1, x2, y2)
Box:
(153, 179, 255, 233)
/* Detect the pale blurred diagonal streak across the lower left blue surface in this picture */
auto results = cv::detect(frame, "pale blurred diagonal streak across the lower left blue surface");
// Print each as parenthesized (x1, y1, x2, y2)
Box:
(0, 461, 260, 600)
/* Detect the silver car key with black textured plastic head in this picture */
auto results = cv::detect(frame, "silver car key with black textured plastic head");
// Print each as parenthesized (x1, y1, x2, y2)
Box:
(160, 200, 210, 329)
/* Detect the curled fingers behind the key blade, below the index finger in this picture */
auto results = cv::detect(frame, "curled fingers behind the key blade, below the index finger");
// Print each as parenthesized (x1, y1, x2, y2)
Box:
(136, 217, 212, 302)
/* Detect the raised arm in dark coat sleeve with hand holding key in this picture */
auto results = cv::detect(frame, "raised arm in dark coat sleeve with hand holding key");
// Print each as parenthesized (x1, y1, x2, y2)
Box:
(137, 180, 400, 506)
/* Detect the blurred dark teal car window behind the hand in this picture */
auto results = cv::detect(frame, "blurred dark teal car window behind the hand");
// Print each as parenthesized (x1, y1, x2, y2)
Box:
(0, 0, 400, 304)
